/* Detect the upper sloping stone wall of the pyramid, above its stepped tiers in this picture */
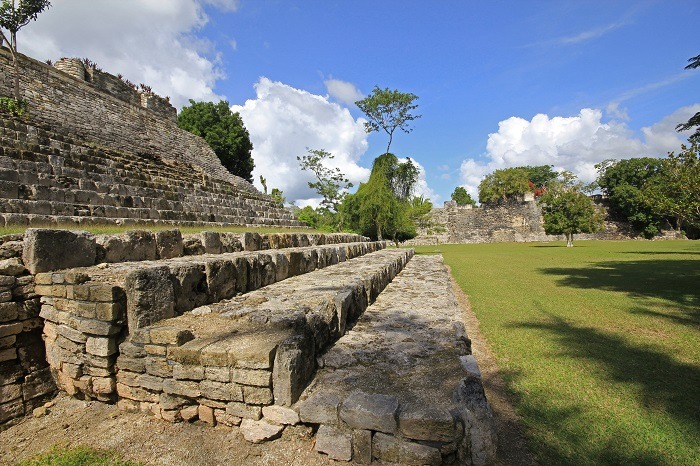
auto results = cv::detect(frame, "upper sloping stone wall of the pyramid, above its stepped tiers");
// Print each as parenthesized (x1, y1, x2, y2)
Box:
(0, 48, 250, 191)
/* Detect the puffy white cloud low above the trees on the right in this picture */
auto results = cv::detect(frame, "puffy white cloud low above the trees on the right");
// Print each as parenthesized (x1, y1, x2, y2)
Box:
(460, 104, 700, 199)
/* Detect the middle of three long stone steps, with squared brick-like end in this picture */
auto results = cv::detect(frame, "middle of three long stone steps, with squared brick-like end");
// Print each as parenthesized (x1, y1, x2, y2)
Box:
(116, 249, 413, 432)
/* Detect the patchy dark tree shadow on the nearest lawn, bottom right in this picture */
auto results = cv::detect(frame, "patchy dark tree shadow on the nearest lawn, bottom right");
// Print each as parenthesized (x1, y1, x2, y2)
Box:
(505, 316, 700, 465)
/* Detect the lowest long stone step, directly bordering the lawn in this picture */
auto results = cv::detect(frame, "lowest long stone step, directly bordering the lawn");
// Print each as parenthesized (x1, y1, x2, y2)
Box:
(294, 256, 496, 465)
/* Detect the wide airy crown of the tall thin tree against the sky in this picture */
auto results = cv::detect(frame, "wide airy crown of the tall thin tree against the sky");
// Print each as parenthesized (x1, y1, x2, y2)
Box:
(355, 86, 421, 153)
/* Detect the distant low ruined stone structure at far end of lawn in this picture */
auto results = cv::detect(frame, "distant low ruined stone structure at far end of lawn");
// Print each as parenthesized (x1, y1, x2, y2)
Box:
(404, 197, 634, 245)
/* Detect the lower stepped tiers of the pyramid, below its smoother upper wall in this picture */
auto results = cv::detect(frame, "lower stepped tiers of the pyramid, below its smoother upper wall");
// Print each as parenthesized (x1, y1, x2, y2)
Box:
(0, 115, 303, 227)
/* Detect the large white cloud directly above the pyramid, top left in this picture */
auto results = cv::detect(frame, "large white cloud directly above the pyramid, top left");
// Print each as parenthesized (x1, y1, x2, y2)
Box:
(19, 0, 230, 107)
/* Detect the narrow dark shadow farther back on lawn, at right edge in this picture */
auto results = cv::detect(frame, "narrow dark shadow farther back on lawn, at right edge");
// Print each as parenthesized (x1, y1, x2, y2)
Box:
(538, 260, 700, 310)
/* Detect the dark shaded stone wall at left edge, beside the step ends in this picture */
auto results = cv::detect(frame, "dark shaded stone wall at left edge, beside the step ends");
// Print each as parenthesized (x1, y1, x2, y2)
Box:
(0, 235, 56, 430)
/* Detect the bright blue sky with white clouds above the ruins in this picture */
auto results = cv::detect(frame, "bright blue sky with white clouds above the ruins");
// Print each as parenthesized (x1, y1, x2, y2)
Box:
(20, 0, 700, 205)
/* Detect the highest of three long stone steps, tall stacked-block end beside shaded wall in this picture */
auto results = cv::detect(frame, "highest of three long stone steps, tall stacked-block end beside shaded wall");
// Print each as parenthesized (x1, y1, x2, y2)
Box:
(37, 242, 385, 401)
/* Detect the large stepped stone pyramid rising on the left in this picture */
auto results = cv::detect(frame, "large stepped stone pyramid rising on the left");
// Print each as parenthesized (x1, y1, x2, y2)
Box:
(0, 48, 300, 226)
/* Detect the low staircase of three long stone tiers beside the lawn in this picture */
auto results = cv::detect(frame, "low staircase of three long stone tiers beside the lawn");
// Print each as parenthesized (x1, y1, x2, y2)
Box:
(6, 230, 495, 464)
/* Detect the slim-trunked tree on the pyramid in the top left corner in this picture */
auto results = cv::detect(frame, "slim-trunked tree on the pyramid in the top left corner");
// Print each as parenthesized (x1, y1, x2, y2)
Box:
(0, 0, 51, 101)
